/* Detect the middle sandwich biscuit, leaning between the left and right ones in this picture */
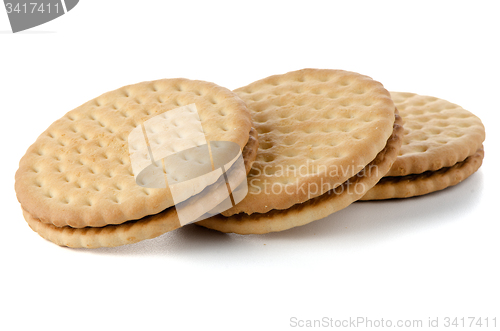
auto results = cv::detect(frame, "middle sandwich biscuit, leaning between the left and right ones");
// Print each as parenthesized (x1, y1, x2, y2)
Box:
(197, 69, 402, 234)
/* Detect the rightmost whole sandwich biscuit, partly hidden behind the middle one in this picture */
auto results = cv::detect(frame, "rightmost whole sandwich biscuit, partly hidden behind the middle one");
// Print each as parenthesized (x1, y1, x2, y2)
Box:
(362, 92, 485, 200)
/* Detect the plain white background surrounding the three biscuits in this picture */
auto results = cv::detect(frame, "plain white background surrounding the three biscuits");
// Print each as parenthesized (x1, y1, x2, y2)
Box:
(0, 0, 500, 330)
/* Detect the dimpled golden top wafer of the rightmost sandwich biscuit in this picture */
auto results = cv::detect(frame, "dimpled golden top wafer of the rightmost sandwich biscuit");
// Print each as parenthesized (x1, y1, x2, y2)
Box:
(386, 92, 485, 176)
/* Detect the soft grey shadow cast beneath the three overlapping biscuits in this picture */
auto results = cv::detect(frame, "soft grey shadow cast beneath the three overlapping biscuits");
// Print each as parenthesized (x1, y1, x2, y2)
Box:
(77, 169, 484, 261)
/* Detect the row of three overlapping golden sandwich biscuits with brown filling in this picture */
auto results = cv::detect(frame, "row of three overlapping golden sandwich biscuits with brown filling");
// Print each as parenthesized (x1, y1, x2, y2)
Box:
(15, 69, 485, 248)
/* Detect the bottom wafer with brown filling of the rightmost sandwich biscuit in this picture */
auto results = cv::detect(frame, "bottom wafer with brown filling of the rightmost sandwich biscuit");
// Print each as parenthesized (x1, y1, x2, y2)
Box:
(360, 148, 484, 200)
